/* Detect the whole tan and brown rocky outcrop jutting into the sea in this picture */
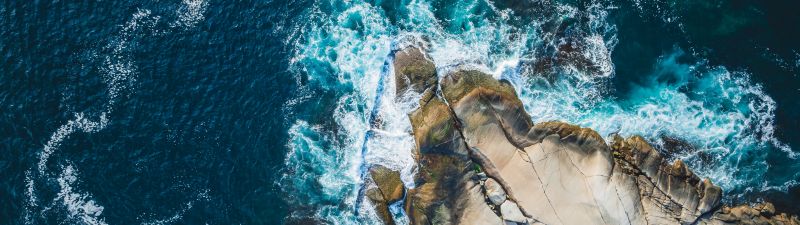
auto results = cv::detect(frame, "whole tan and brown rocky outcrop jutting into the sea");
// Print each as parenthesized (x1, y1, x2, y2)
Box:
(368, 48, 800, 224)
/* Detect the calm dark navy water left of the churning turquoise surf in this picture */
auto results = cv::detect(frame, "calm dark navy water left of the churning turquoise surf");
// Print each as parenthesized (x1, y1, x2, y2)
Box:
(0, 1, 298, 224)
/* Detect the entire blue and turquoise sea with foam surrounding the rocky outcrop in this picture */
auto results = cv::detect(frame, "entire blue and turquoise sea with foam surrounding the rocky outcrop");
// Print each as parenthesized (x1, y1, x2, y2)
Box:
(0, 0, 800, 224)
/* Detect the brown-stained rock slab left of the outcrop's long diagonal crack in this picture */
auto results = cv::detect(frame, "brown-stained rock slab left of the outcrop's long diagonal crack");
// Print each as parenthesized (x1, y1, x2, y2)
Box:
(395, 49, 502, 224)
